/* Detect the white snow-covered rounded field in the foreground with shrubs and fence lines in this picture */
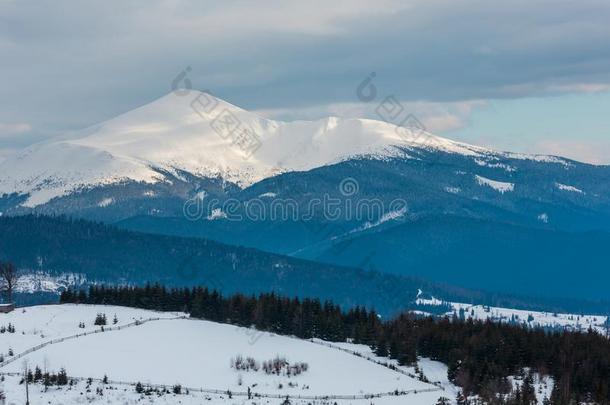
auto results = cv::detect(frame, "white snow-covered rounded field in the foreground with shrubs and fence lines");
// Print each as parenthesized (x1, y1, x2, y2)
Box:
(0, 305, 446, 405)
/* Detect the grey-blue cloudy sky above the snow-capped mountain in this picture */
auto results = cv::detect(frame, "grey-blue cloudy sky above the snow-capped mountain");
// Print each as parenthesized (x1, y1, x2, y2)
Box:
(0, 0, 610, 164)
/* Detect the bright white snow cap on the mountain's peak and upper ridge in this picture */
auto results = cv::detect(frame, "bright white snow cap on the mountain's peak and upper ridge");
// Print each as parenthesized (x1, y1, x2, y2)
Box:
(0, 91, 567, 207)
